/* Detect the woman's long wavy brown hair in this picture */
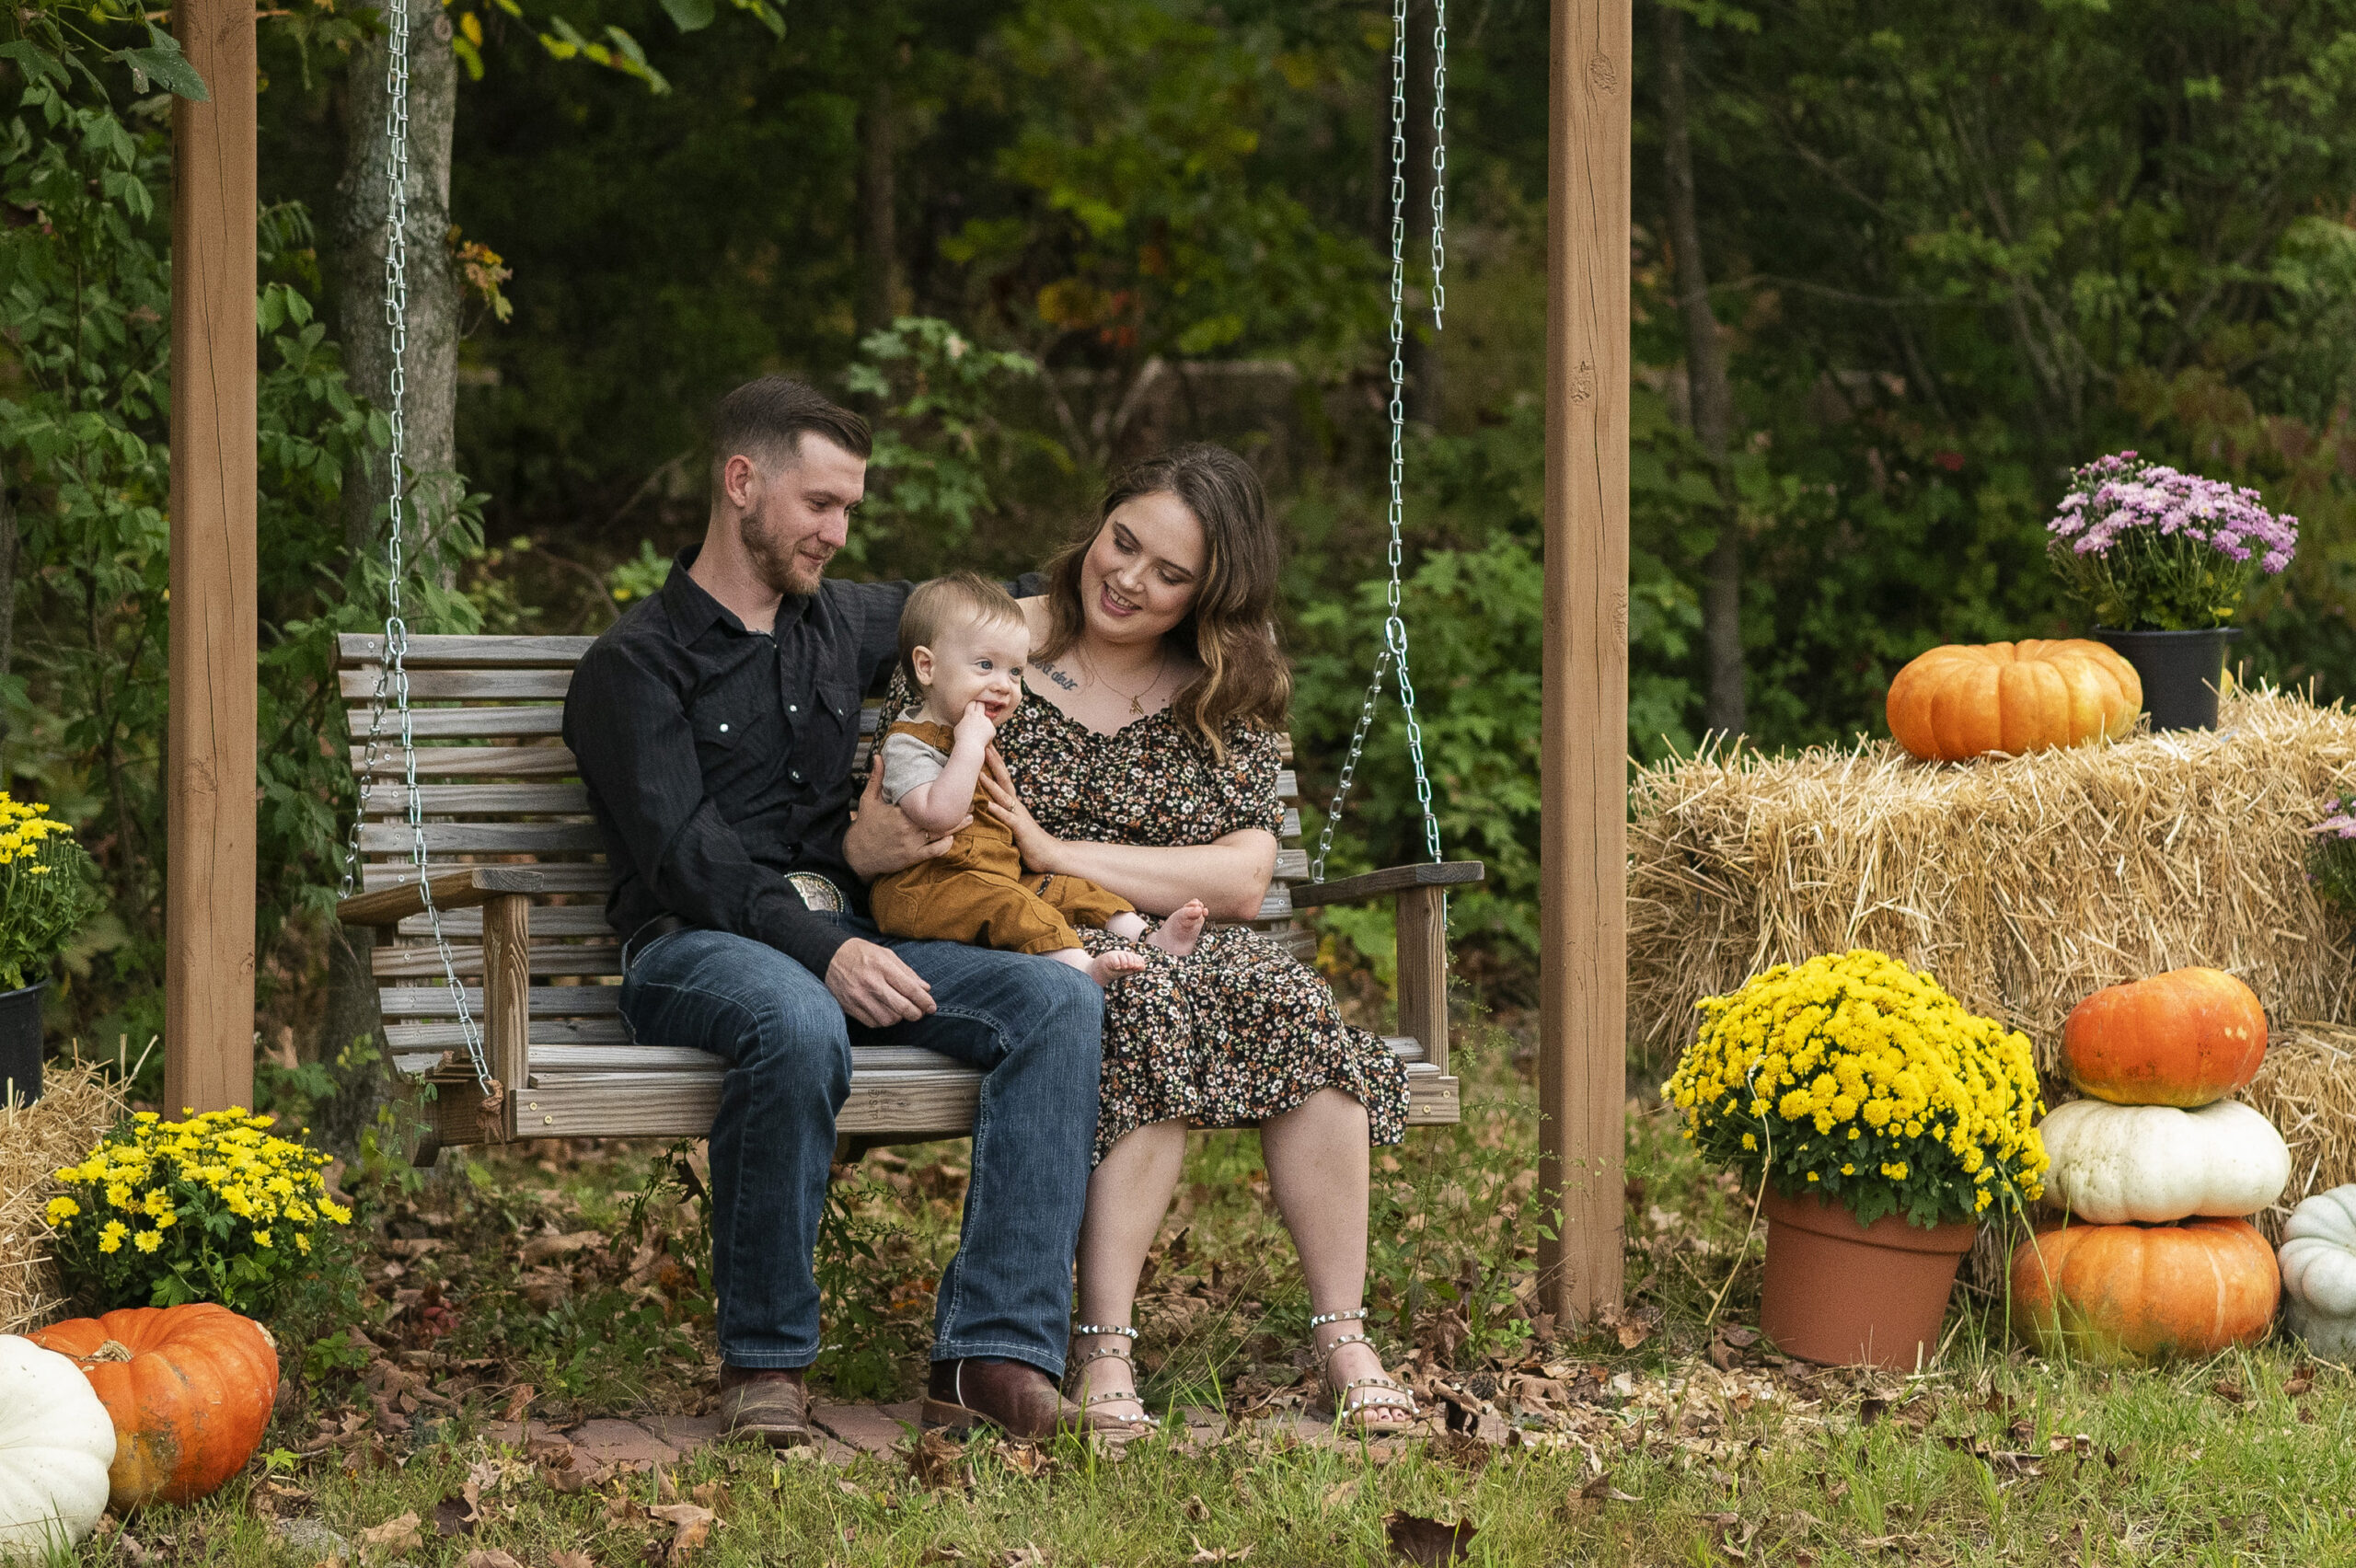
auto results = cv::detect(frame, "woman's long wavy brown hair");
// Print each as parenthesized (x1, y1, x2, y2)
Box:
(1034, 445, 1293, 760)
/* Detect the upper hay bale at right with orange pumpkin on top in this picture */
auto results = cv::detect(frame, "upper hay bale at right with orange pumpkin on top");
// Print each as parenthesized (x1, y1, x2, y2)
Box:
(1628, 690, 2356, 1073)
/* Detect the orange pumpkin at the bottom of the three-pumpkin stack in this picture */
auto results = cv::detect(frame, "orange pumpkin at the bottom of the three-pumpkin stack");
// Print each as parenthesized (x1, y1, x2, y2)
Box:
(2012, 1219, 2283, 1361)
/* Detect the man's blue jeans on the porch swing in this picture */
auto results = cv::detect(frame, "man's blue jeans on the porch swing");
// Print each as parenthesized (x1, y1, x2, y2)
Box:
(622, 916, 1105, 1378)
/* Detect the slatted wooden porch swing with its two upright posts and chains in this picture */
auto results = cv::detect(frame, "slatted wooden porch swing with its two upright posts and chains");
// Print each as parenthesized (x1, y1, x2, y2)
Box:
(165, 0, 1631, 1320)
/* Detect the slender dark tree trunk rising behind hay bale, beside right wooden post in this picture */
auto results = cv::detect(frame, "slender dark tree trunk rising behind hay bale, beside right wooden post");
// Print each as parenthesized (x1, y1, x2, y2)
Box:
(1658, 5, 1743, 734)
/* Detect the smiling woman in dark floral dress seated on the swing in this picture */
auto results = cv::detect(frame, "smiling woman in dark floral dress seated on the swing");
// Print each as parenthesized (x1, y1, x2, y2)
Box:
(992, 445, 1414, 1432)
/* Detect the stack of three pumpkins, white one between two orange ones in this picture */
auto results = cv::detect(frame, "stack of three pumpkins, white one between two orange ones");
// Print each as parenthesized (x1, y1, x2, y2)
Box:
(2012, 970, 2290, 1361)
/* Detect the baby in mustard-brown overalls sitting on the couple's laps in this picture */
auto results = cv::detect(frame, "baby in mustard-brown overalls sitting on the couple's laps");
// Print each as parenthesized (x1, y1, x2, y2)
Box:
(874, 572, 1208, 984)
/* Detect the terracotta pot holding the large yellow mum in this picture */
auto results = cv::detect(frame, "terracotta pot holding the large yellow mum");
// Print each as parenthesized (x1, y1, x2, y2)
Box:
(1760, 1187, 1979, 1373)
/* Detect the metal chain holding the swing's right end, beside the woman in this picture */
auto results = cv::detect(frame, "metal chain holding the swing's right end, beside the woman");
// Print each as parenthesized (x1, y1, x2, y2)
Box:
(1310, 0, 1447, 882)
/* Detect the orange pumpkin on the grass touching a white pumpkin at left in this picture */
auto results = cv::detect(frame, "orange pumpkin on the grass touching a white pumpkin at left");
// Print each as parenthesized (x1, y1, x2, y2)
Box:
(30, 1302, 278, 1509)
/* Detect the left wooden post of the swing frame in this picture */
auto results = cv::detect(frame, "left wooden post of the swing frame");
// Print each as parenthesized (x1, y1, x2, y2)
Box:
(163, 0, 260, 1113)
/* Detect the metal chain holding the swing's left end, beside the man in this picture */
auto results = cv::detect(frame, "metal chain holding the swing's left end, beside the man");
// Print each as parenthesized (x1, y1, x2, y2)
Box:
(344, 0, 502, 1121)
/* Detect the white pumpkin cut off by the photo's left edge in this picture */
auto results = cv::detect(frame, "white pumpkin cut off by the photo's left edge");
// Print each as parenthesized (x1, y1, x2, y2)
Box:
(0, 1335, 115, 1563)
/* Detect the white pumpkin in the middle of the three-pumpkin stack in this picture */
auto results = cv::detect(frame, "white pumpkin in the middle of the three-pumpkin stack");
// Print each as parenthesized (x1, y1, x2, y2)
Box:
(2038, 1100, 2290, 1224)
